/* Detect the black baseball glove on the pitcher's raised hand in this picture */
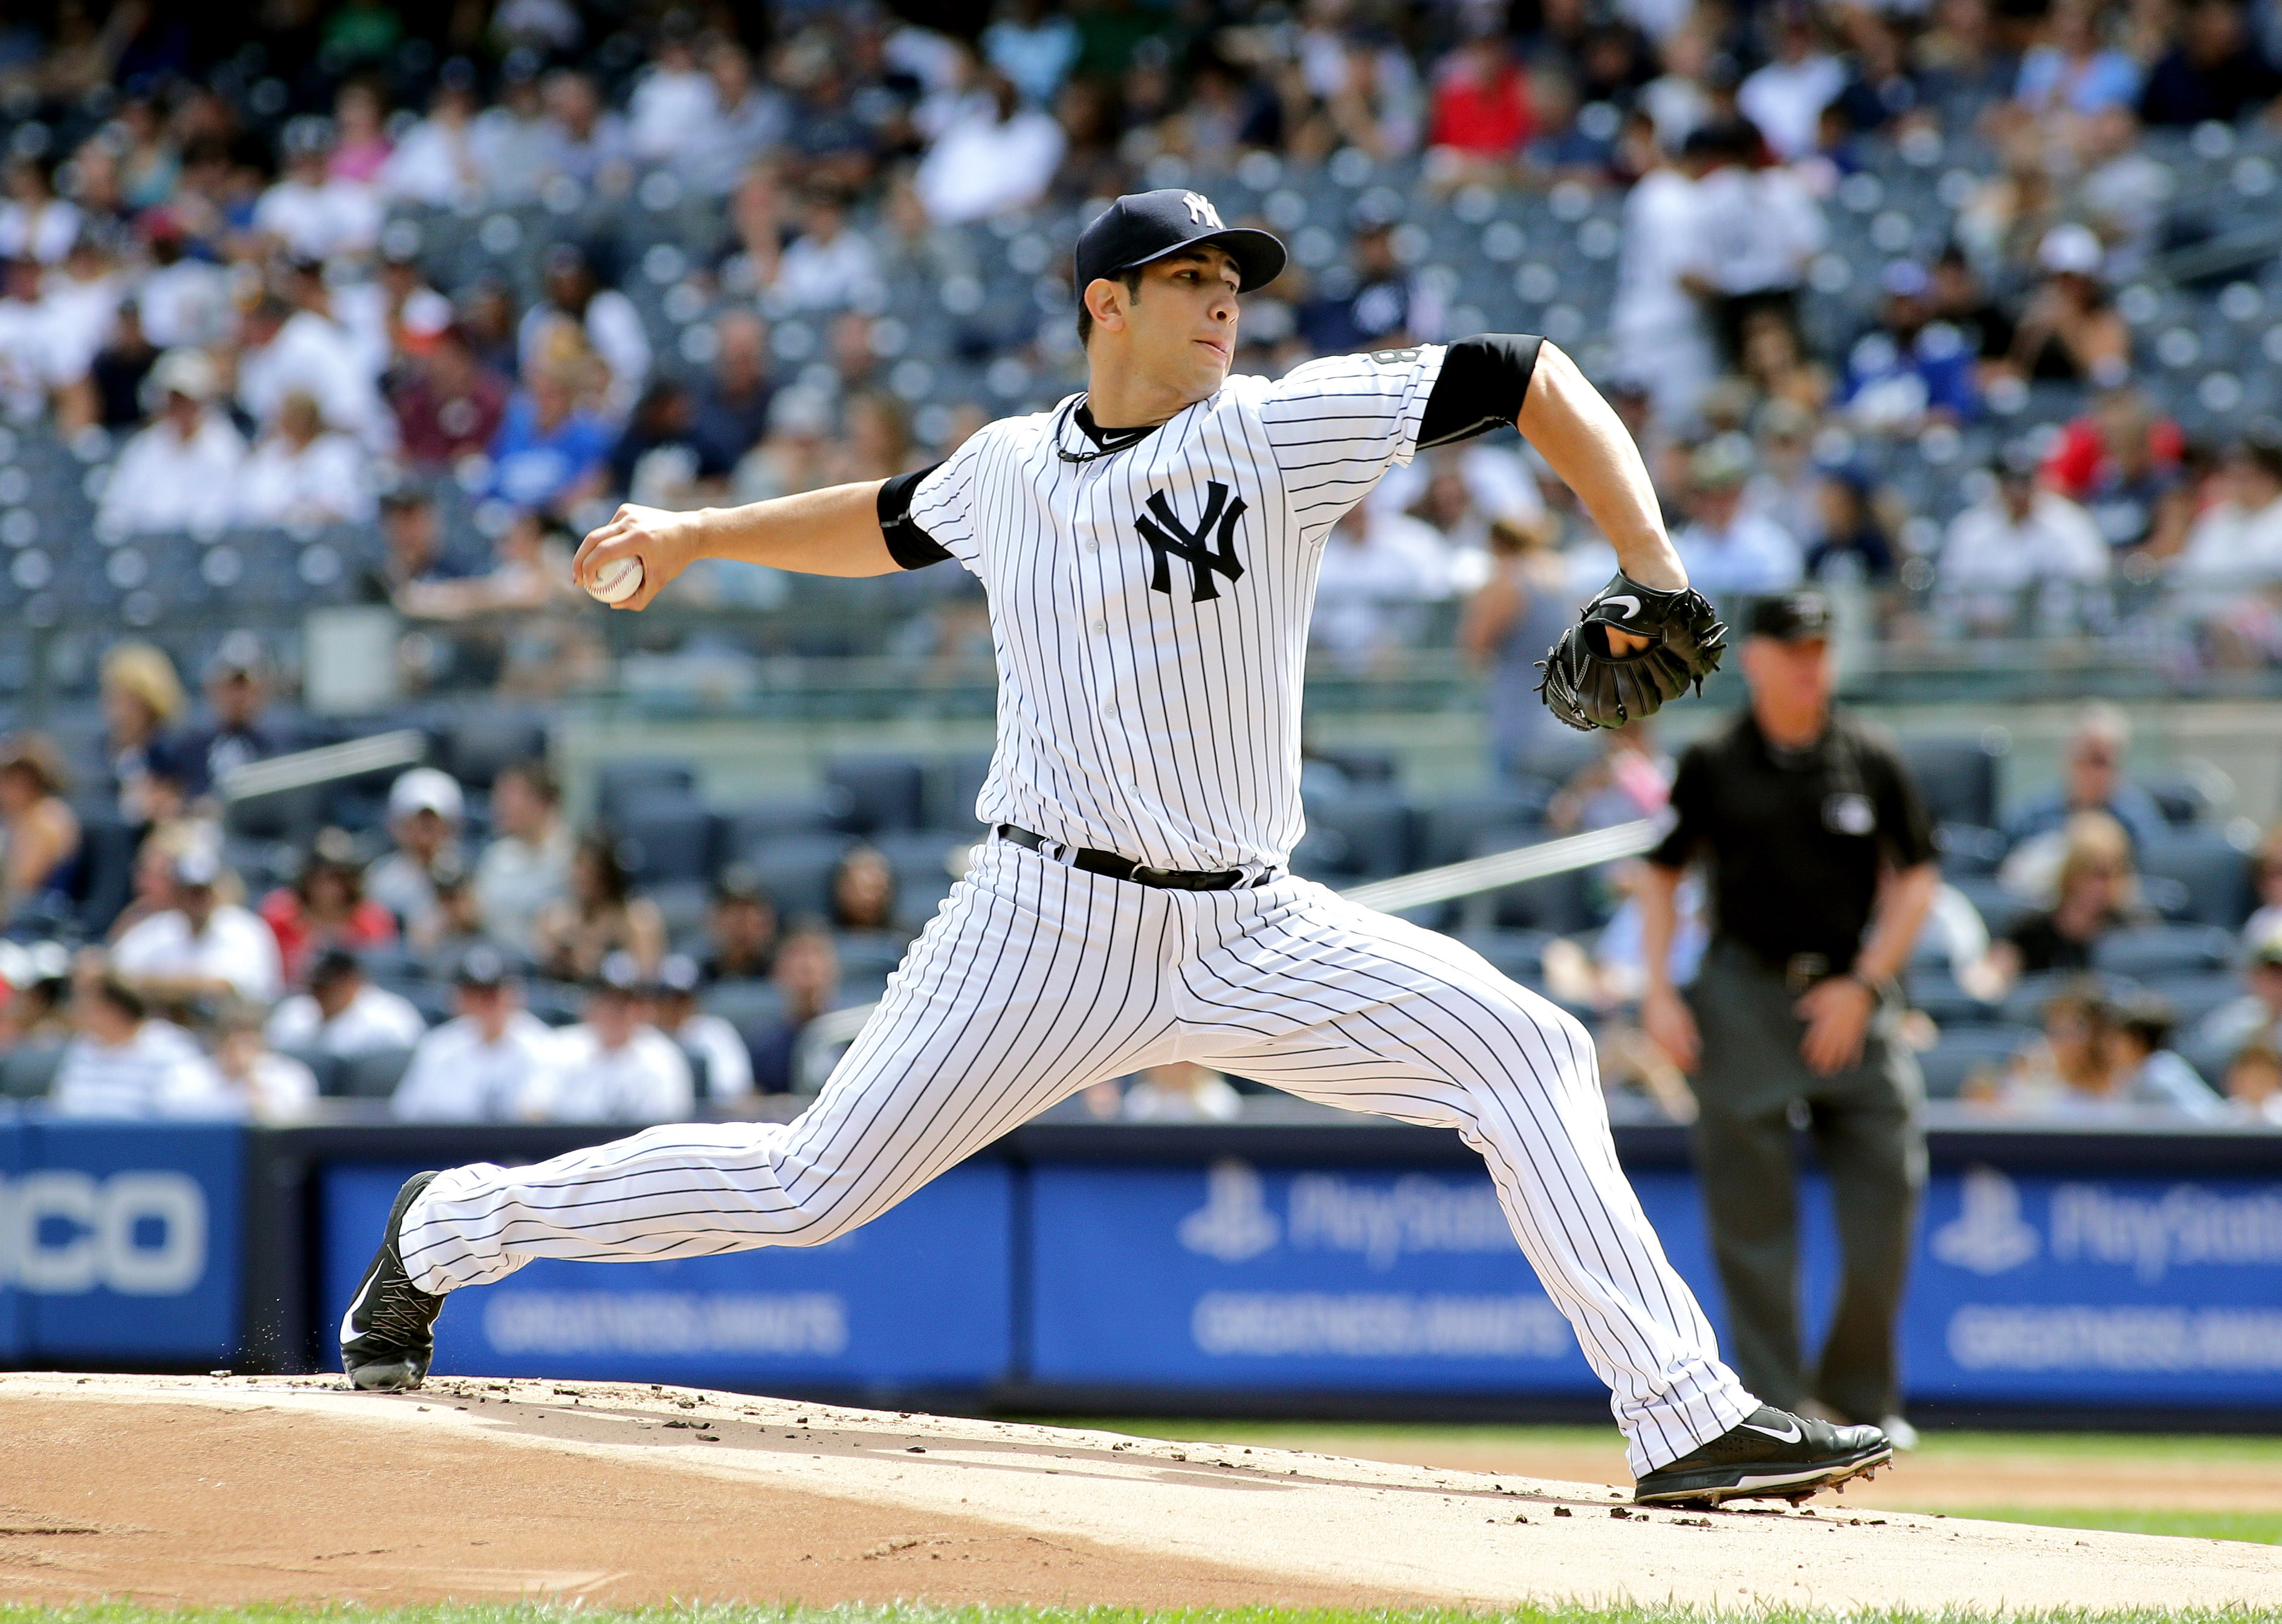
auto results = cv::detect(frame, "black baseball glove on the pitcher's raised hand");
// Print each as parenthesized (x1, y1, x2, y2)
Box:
(1538, 570, 1727, 732)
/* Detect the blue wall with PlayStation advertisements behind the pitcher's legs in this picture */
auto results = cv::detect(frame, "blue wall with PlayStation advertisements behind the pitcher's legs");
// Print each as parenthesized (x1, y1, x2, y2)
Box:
(0, 1118, 2282, 1412)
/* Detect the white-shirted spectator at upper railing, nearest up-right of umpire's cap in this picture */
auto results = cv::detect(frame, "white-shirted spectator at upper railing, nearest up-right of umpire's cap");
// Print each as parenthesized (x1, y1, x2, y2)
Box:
(1933, 447, 2109, 632)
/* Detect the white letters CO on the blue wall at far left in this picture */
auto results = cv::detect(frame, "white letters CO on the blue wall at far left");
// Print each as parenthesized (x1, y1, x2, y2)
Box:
(0, 1168, 205, 1298)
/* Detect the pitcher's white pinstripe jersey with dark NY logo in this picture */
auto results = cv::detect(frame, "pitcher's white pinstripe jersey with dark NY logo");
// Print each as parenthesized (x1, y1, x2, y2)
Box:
(911, 344, 1442, 869)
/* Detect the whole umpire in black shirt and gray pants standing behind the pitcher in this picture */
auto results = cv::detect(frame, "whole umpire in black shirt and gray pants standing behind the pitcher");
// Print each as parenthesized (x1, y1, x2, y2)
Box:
(1641, 591, 1938, 1423)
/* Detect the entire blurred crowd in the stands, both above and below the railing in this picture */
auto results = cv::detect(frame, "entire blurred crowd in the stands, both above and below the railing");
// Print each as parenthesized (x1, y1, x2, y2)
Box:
(0, 0, 2282, 1136)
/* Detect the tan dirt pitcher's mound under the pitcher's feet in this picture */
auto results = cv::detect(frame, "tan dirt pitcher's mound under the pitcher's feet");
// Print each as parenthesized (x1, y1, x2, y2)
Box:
(0, 1375, 2282, 1608)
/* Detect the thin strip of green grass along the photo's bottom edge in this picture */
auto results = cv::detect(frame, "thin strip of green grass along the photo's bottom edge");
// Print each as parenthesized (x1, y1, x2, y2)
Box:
(0, 1601, 2282, 1624)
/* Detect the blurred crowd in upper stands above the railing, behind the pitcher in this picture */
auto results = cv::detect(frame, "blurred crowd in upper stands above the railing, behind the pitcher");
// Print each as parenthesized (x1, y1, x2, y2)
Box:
(0, 0, 2282, 694)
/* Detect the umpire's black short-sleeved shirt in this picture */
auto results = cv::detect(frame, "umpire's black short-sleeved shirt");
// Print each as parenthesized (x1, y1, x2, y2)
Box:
(1647, 709, 1933, 969)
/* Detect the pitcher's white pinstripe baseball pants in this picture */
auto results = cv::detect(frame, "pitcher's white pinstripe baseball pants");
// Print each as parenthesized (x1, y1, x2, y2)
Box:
(404, 842, 1757, 1471)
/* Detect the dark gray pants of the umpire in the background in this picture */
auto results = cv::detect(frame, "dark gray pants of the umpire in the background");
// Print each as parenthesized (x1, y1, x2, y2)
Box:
(1689, 939, 1926, 1421)
